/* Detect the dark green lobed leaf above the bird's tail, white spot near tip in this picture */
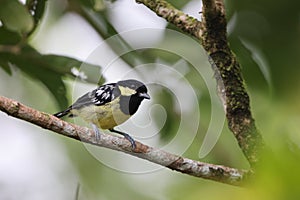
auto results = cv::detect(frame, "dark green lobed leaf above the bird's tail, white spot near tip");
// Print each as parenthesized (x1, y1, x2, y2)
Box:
(0, 46, 103, 109)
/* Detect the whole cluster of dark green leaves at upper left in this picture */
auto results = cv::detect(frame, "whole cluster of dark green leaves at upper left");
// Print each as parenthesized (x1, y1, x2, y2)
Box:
(0, 0, 100, 109)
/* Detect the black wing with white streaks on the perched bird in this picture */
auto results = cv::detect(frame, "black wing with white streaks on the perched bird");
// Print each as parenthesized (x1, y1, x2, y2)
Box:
(70, 83, 120, 109)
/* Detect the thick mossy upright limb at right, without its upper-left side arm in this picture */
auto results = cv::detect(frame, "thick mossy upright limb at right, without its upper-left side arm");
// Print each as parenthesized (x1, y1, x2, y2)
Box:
(201, 0, 264, 166)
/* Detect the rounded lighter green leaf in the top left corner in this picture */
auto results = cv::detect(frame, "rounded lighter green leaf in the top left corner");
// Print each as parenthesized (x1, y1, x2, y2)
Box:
(0, 0, 34, 33)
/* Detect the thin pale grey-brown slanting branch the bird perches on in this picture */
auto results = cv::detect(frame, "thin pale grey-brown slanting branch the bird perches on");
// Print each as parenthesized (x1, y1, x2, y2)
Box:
(0, 96, 252, 185)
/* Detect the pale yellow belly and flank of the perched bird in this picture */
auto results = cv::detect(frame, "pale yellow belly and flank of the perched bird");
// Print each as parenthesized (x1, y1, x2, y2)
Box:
(71, 98, 130, 129)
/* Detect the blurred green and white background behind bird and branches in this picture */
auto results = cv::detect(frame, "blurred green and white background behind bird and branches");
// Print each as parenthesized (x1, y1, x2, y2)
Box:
(0, 0, 300, 200)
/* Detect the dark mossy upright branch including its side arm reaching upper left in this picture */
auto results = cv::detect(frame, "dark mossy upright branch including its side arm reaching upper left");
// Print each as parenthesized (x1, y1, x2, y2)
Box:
(136, 0, 264, 166)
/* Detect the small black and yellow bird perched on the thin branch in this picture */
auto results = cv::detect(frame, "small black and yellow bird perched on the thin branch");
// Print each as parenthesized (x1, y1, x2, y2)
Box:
(54, 79, 150, 149)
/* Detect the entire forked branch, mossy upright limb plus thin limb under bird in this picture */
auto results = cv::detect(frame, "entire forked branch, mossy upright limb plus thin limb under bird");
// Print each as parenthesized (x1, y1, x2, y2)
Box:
(0, 0, 264, 188)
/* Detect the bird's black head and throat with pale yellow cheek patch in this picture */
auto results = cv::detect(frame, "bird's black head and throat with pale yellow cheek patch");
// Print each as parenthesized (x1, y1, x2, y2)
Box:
(117, 79, 150, 115)
